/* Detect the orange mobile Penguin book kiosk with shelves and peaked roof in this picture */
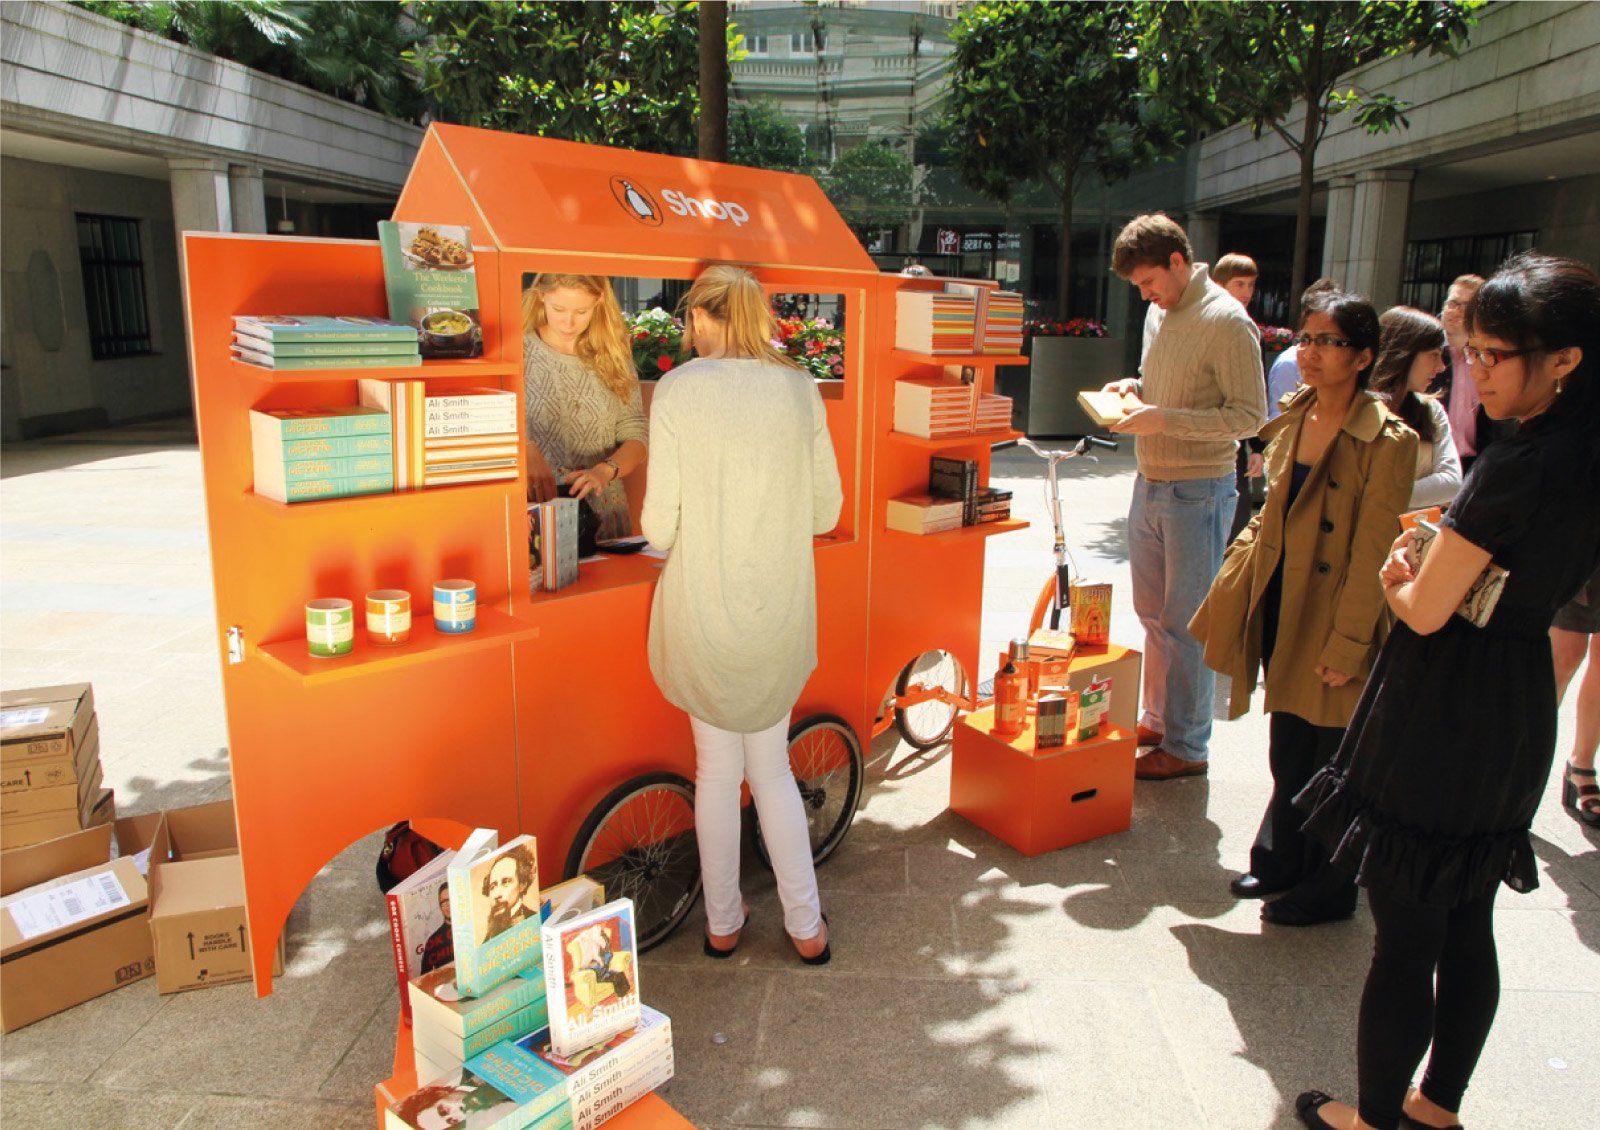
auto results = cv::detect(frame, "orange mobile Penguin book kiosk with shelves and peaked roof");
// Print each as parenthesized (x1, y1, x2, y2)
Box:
(175, 125, 1022, 1107)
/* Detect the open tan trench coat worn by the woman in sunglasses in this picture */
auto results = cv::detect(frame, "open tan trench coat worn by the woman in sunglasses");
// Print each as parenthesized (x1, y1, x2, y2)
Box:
(1189, 386, 1418, 727)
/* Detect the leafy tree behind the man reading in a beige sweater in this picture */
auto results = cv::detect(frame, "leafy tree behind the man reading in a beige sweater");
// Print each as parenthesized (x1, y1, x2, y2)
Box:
(946, 0, 1182, 319)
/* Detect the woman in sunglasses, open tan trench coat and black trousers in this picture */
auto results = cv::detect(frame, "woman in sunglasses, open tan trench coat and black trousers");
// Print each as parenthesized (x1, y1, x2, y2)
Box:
(1189, 291, 1418, 925)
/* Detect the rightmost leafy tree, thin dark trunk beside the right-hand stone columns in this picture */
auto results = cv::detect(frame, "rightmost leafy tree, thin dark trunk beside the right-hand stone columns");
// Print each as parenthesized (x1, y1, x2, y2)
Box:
(1146, 0, 1482, 320)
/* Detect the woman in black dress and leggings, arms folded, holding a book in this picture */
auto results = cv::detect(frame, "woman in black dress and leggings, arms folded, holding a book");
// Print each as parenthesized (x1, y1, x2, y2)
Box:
(1296, 251, 1600, 1130)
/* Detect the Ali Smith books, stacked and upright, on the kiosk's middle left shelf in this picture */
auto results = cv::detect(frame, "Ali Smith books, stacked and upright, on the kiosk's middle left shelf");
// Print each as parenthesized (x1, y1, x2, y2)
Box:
(360, 379, 518, 491)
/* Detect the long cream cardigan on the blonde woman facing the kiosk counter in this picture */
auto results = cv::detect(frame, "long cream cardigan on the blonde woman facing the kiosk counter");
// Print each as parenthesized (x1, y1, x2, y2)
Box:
(640, 359, 843, 733)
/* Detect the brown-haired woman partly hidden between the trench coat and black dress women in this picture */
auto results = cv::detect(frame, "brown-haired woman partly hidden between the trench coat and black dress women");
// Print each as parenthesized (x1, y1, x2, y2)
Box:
(1373, 306, 1461, 511)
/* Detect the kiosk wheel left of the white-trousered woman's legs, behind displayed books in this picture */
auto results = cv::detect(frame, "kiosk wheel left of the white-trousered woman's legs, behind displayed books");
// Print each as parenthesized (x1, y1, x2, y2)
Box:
(565, 773, 701, 951)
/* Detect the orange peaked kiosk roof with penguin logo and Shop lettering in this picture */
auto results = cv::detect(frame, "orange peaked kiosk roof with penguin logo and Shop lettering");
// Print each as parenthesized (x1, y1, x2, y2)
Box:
(395, 123, 877, 274)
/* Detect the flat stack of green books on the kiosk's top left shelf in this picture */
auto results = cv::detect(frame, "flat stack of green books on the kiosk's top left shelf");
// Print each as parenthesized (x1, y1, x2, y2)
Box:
(232, 314, 422, 371)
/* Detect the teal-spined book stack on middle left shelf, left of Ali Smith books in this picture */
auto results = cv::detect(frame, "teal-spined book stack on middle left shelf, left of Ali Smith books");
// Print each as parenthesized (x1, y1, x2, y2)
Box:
(250, 405, 395, 503)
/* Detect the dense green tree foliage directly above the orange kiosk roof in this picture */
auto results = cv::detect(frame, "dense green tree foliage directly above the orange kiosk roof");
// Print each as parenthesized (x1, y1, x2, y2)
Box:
(411, 0, 733, 155)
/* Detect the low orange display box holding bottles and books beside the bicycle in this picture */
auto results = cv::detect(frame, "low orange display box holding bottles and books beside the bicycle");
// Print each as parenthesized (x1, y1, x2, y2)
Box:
(950, 707, 1136, 855)
